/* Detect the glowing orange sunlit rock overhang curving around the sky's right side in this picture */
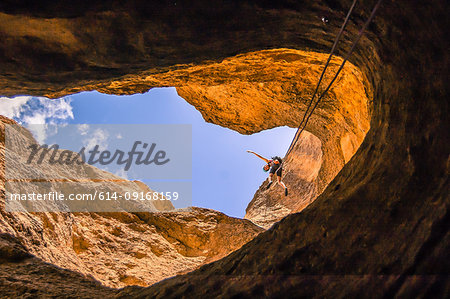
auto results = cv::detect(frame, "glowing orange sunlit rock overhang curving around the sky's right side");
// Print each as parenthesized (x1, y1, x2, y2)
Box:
(47, 49, 372, 228)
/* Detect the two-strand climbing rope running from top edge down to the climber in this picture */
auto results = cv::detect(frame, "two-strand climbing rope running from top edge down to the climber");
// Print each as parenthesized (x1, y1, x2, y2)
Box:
(280, 0, 383, 167)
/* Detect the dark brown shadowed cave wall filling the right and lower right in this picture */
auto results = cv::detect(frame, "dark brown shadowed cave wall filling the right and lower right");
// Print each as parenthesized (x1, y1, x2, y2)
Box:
(123, 1, 450, 298)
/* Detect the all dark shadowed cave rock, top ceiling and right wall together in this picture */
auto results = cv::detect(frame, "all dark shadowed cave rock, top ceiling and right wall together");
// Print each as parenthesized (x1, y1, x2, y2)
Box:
(1, 0, 450, 298)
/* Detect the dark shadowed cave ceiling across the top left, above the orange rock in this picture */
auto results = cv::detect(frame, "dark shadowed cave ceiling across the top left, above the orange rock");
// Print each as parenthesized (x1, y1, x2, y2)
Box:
(0, 0, 370, 96)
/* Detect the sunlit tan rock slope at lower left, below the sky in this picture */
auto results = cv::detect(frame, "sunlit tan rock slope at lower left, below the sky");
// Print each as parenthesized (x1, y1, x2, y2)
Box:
(0, 116, 262, 287)
